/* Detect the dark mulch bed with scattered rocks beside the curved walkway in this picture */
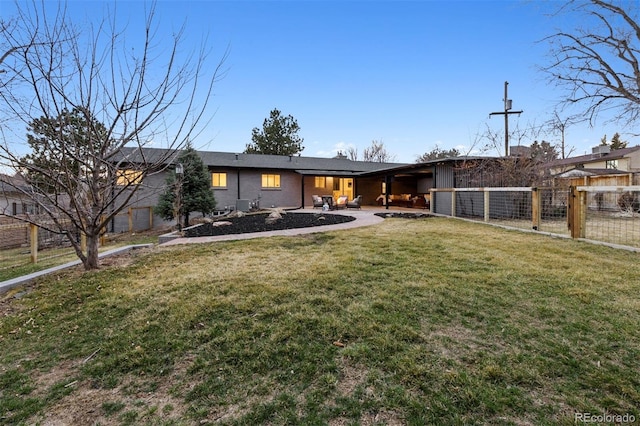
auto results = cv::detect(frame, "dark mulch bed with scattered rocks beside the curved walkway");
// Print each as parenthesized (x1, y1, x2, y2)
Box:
(183, 213, 356, 237)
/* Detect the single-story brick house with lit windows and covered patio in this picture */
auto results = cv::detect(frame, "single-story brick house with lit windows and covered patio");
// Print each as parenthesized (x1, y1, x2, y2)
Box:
(110, 148, 500, 232)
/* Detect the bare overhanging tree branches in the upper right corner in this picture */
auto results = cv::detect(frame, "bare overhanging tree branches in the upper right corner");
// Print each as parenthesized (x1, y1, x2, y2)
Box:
(544, 0, 640, 128)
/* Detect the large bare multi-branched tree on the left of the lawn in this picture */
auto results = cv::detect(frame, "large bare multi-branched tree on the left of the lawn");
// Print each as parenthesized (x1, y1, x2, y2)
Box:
(0, 2, 226, 269)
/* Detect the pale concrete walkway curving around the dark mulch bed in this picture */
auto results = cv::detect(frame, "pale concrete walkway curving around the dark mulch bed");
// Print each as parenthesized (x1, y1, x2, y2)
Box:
(161, 207, 390, 247)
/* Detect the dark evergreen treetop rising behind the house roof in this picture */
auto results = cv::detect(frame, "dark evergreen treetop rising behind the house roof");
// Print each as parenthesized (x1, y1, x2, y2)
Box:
(244, 109, 304, 155)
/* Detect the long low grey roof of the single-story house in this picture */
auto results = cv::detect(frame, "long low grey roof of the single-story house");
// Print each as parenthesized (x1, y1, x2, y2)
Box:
(121, 147, 407, 175)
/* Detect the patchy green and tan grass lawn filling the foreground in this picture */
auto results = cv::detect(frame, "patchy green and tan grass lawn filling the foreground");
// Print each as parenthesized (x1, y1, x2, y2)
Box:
(0, 218, 640, 425)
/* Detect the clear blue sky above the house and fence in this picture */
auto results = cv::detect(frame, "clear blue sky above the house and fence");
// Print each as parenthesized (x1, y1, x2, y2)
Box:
(0, 0, 640, 163)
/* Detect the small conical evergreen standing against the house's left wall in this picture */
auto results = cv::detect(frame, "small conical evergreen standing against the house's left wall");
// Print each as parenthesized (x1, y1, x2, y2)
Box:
(155, 142, 216, 226)
